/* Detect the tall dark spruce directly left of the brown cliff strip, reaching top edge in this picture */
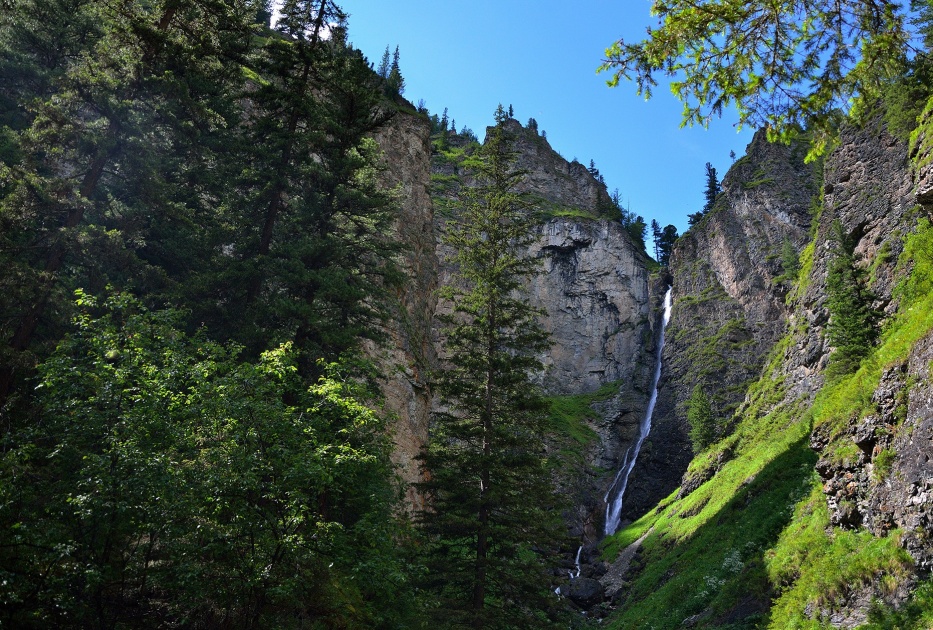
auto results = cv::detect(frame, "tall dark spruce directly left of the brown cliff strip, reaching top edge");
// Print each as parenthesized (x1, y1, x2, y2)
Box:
(190, 0, 396, 380)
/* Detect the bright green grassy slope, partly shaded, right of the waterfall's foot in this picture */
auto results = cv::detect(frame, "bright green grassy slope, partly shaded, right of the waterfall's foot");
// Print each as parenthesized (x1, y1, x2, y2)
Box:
(604, 220, 933, 629)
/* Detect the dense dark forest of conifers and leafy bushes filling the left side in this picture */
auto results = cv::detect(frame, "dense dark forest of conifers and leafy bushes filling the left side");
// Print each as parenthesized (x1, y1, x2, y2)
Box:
(0, 0, 426, 628)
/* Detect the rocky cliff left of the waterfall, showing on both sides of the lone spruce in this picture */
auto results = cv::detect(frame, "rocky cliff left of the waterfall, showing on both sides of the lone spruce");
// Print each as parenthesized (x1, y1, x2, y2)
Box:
(371, 114, 663, 542)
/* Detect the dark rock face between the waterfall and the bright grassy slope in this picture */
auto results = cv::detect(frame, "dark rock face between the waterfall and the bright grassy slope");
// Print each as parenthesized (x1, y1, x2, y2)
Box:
(626, 132, 818, 516)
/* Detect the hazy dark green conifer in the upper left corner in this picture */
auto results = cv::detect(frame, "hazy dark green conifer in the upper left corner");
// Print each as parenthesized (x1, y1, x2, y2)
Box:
(0, 0, 255, 404)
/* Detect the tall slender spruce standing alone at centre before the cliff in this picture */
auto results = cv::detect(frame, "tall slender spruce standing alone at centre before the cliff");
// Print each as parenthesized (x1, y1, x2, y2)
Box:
(419, 106, 560, 628)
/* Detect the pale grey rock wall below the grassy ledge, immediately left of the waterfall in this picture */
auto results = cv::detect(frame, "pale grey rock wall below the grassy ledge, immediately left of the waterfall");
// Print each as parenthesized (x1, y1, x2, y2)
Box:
(528, 218, 654, 542)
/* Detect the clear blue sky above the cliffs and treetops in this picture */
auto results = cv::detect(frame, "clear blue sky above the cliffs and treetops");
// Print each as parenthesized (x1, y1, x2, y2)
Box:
(340, 0, 752, 232)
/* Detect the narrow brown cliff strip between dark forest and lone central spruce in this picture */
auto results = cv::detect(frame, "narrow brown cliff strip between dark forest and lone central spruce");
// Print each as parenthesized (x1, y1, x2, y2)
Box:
(369, 113, 438, 507)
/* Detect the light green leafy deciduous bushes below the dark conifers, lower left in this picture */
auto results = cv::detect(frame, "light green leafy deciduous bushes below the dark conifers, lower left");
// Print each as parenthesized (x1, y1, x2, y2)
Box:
(0, 294, 416, 628)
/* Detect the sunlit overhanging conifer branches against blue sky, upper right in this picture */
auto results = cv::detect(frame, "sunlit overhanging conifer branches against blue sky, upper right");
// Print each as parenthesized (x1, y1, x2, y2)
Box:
(600, 0, 929, 148)
